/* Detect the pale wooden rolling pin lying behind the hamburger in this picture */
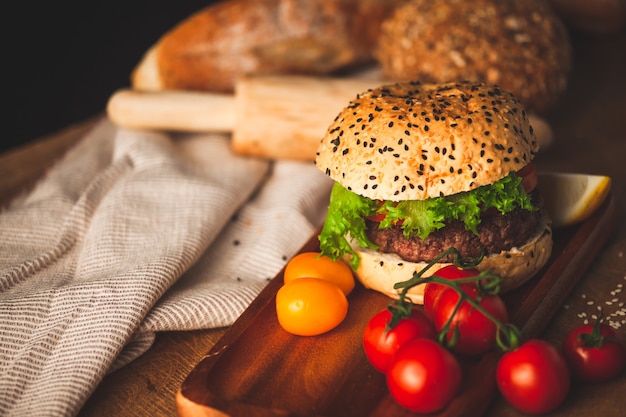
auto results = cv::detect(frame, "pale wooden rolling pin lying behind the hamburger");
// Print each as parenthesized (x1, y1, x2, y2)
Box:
(107, 75, 552, 160)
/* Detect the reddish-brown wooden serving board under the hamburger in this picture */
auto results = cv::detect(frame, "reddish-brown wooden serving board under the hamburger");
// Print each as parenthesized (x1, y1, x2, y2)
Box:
(176, 195, 616, 417)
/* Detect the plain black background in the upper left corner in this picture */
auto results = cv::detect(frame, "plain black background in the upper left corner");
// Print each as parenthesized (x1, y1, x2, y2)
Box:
(6, 0, 211, 152)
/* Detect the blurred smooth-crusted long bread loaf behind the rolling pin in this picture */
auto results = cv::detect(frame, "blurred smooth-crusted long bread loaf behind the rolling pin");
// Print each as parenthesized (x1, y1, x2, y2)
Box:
(131, 0, 405, 93)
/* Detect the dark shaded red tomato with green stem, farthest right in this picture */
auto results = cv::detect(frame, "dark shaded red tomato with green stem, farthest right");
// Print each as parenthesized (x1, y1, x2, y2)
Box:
(561, 322, 626, 382)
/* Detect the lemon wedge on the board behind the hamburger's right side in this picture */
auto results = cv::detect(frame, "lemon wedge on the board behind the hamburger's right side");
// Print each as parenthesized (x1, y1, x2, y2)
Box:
(537, 172, 611, 227)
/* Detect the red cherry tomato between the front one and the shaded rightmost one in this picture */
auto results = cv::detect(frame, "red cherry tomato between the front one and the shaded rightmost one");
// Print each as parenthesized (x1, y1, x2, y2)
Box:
(496, 339, 570, 414)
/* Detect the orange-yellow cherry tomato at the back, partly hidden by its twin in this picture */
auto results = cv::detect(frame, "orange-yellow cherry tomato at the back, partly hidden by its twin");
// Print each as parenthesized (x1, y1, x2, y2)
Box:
(285, 252, 354, 295)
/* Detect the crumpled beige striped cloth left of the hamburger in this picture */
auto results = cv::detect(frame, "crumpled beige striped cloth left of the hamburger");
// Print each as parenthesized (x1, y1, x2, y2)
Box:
(0, 120, 331, 416)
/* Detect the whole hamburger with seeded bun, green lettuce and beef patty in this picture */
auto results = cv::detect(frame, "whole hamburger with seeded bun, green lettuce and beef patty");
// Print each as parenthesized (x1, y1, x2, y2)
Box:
(315, 82, 552, 304)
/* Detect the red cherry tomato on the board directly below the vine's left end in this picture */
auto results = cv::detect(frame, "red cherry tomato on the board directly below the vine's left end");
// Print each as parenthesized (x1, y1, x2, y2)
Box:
(387, 339, 461, 413)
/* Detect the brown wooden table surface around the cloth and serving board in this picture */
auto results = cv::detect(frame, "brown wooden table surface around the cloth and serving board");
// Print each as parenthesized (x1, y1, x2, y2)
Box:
(0, 30, 626, 417)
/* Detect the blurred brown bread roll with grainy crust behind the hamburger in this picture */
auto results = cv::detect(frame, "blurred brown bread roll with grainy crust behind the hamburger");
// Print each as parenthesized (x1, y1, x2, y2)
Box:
(376, 0, 571, 114)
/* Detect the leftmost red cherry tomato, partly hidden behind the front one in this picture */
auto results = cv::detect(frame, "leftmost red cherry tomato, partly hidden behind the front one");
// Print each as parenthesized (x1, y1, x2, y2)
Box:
(363, 308, 436, 372)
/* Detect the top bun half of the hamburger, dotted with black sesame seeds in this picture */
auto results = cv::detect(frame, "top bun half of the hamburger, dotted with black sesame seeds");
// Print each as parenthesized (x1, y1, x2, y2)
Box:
(315, 82, 538, 201)
